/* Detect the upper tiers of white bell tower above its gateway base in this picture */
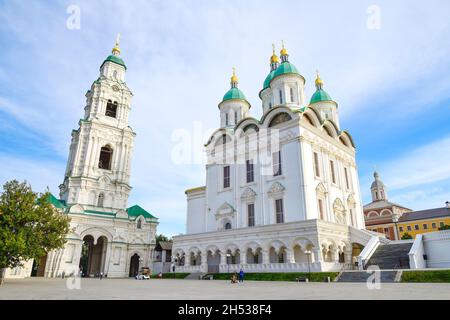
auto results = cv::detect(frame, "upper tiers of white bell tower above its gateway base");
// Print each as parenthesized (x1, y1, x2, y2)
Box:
(59, 35, 136, 212)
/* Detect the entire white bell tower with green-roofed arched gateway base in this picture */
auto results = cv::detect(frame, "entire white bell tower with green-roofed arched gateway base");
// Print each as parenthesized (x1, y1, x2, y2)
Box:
(34, 40, 158, 277)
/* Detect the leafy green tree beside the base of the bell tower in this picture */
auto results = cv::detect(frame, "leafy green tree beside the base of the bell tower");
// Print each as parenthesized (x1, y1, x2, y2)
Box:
(0, 180, 70, 285)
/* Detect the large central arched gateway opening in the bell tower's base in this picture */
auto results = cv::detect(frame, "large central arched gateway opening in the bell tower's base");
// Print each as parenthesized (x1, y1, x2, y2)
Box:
(79, 235, 108, 277)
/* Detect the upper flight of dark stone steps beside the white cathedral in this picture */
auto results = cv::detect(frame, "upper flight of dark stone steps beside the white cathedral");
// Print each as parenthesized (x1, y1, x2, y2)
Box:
(364, 242, 413, 269)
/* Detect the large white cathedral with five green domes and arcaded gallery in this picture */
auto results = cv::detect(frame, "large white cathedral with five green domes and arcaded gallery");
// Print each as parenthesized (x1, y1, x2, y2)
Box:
(172, 44, 379, 272)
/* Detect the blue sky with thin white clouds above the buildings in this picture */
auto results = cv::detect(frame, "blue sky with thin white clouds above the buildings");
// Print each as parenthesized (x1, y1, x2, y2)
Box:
(0, 0, 450, 235)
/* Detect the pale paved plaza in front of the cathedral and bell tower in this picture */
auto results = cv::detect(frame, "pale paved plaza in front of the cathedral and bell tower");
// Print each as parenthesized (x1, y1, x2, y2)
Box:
(0, 278, 450, 300)
